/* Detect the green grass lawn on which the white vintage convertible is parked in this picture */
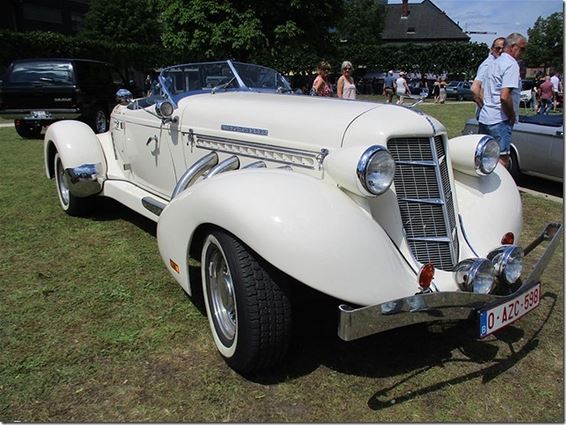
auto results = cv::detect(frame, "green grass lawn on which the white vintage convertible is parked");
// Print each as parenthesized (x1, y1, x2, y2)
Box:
(0, 104, 564, 422)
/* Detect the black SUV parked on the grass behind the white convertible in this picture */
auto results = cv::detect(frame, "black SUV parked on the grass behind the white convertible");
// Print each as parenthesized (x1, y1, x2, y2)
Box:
(0, 59, 135, 138)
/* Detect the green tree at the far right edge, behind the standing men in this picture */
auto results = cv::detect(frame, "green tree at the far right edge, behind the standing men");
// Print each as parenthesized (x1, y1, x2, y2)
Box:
(524, 12, 564, 72)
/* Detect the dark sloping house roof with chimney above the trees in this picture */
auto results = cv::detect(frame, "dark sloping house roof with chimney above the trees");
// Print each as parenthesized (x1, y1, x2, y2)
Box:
(382, 0, 470, 42)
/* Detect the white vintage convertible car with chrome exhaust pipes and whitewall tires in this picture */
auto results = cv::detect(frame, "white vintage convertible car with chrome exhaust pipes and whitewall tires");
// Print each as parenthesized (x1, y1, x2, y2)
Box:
(45, 61, 562, 373)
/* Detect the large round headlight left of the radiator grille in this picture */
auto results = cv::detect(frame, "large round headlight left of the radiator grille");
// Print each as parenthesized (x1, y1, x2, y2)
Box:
(356, 145, 395, 195)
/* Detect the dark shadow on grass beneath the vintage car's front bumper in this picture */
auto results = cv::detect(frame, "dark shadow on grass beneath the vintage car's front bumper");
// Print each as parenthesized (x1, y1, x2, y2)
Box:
(252, 292, 557, 398)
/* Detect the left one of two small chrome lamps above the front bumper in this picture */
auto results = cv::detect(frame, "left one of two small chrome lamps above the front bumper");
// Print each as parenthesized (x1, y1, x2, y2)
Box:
(454, 258, 495, 294)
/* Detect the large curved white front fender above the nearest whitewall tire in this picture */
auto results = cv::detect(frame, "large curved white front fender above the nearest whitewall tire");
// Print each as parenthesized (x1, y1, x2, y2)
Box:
(157, 169, 417, 305)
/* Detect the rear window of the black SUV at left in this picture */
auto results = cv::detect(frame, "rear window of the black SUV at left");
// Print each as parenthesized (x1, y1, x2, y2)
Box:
(7, 61, 74, 85)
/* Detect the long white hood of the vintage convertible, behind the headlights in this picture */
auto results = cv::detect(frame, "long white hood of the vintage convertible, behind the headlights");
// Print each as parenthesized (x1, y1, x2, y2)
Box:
(179, 92, 442, 149)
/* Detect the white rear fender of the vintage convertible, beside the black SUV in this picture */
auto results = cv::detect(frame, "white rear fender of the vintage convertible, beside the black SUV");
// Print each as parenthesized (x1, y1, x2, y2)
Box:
(43, 120, 107, 179)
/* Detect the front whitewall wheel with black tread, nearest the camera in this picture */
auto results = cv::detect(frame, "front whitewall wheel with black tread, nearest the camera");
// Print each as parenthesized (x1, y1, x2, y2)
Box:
(201, 230, 291, 374)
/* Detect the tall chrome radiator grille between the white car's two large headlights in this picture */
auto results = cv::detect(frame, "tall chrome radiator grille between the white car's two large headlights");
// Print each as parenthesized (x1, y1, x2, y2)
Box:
(387, 136, 458, 270)
